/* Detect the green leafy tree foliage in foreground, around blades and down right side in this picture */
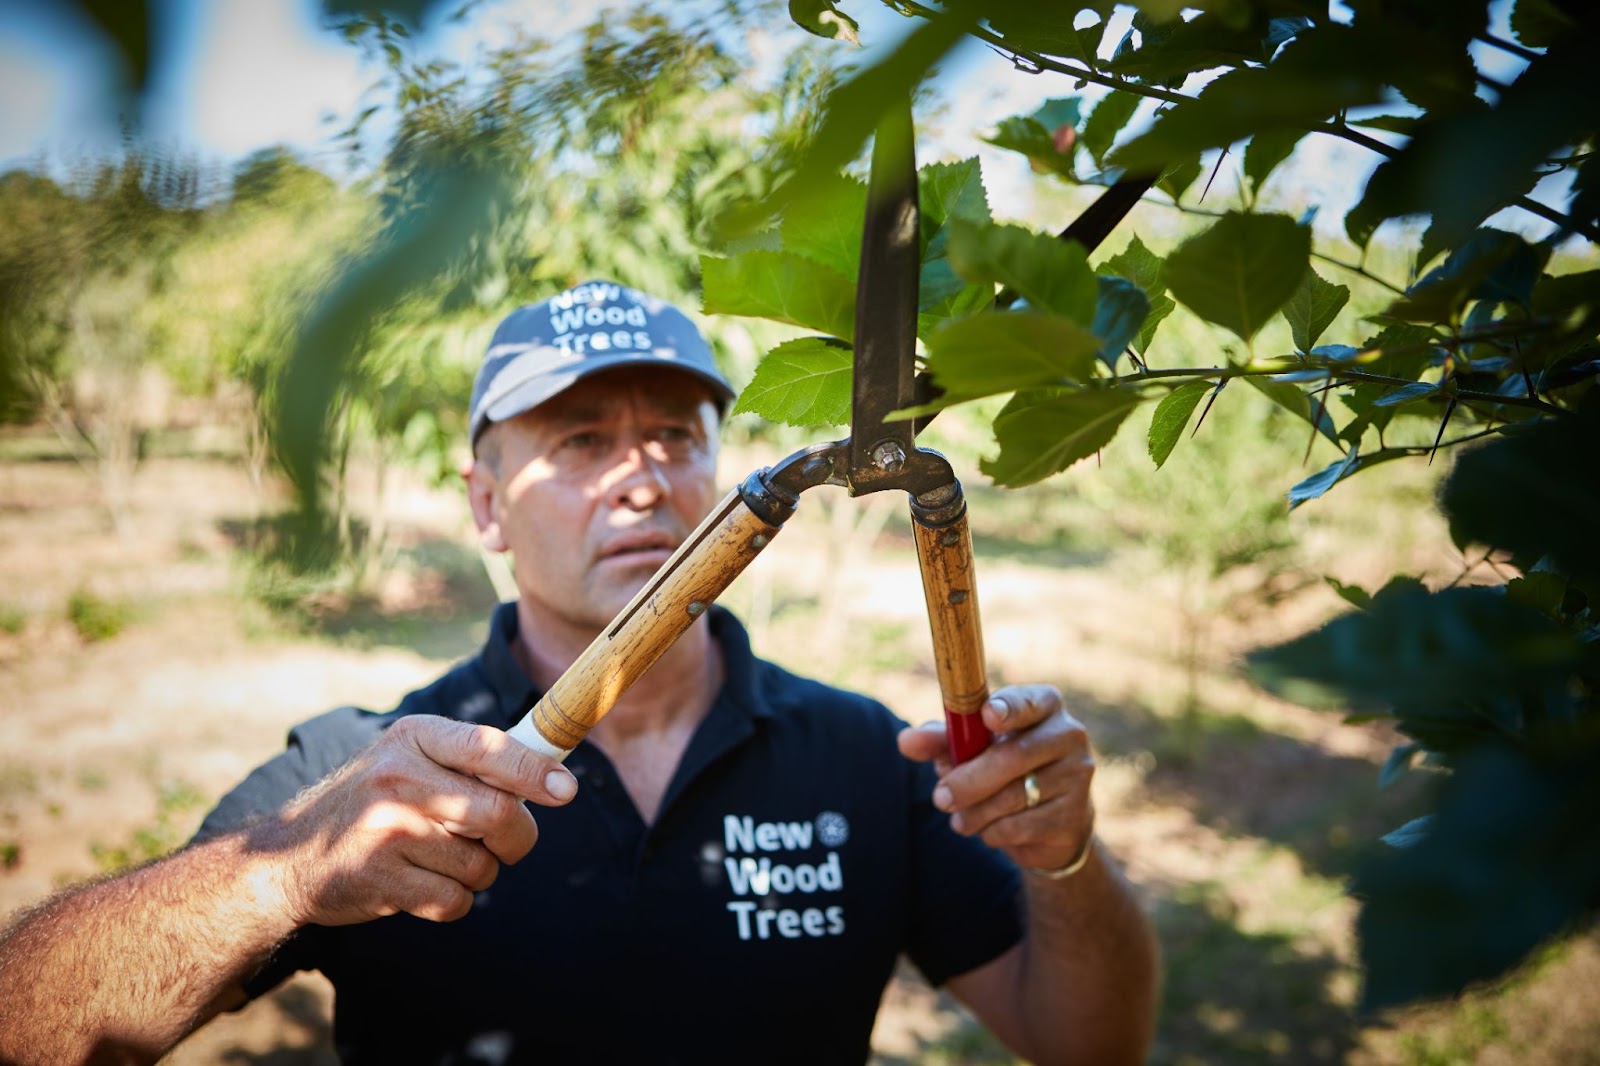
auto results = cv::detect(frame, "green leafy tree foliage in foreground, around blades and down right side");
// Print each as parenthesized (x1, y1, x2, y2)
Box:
(706, 0, 1600, 1007)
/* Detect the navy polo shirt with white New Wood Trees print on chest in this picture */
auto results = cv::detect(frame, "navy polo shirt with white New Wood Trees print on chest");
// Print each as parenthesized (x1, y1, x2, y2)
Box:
(197, 603, 1022, 1063)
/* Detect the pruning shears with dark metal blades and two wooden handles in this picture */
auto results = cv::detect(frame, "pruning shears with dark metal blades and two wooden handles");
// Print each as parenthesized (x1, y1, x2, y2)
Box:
(509, 101, 1150, 763)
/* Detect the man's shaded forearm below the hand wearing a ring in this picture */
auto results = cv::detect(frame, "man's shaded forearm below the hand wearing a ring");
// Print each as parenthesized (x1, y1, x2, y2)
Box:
(1016, 844, 1160, 1064)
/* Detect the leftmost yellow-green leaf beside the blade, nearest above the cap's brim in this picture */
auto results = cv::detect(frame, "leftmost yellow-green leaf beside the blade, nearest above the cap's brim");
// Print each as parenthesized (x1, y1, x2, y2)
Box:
(701, 251, 856, 341)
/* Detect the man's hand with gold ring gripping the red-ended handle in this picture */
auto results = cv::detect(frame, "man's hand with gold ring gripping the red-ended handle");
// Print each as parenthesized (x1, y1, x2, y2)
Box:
(899, 685, 1094, 871)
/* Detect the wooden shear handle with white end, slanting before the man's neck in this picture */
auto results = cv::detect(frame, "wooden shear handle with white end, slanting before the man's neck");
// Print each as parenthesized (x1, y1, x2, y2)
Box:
(507, 490, 778, 759)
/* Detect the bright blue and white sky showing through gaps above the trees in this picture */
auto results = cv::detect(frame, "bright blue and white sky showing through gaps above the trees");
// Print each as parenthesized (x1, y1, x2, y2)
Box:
(0, 0, 1548, 243)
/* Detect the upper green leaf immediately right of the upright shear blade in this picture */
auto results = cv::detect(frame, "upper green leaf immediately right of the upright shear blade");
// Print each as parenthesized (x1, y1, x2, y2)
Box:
(950, 221, 1099, 325)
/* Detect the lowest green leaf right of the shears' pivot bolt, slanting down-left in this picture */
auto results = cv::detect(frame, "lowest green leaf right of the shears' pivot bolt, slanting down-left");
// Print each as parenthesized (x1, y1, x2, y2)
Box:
(979, 389, 1139, 488)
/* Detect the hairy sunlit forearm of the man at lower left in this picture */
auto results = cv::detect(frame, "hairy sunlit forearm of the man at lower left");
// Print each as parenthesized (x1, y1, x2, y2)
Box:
(0, 834, 294, 1063)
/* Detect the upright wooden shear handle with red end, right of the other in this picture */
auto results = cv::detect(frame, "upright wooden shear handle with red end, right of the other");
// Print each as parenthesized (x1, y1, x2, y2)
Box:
(910, 507, 994, 763)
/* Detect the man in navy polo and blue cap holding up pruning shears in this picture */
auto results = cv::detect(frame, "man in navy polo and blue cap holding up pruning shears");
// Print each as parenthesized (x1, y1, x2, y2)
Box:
(0, 282, 1155, 1064)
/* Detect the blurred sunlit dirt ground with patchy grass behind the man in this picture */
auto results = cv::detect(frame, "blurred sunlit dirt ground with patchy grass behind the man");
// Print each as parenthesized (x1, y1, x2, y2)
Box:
(0, 435, 1600, 1064)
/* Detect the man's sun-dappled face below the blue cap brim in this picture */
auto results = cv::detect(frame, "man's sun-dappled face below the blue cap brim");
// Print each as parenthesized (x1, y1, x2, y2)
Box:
(469, 368, 717, 631)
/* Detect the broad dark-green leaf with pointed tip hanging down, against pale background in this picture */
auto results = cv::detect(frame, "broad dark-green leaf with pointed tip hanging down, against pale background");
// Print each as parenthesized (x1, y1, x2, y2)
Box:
(1163, 211, 1310, 343)
